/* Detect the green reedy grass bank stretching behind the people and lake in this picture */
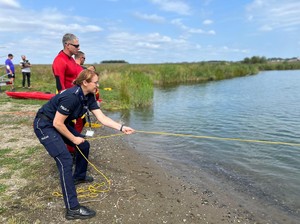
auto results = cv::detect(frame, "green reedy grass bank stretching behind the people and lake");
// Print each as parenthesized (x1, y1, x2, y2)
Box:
(1, 62, 300, 110)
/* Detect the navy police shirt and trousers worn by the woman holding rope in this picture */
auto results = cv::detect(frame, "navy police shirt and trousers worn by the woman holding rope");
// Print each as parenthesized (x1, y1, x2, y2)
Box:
(34, 85, 99, 209)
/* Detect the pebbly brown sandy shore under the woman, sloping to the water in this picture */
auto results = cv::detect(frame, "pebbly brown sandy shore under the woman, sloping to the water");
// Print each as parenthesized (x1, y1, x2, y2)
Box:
(0, 102, 296, 224)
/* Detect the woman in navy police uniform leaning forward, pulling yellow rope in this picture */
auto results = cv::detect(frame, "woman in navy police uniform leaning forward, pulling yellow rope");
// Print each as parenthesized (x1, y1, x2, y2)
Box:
(34, 69, 134, 219)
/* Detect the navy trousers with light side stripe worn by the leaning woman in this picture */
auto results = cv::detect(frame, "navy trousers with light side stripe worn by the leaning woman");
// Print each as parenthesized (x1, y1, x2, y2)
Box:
(33, 117, 90, 209)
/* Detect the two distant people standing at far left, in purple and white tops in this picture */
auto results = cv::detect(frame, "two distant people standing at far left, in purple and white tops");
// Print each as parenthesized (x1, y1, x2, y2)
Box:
(5, 54, 31, 91)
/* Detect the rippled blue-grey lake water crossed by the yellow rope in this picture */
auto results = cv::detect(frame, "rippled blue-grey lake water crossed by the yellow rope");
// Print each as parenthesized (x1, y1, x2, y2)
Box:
(104, 71, 300, 222)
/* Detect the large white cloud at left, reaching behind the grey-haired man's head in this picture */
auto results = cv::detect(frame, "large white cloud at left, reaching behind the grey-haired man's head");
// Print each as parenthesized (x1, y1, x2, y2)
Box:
(0, 0, 103, 63)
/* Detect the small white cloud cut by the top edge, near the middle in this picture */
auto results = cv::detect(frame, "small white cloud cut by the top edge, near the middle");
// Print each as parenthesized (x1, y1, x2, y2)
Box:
(150, 0, 191, 15)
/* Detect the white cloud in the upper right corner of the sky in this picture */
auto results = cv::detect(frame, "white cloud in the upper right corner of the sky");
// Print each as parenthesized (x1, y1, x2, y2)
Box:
(246, 0, 300, 31)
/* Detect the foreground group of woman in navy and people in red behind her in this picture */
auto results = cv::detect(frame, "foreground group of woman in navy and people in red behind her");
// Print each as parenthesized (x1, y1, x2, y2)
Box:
(33, 33, 134, 220)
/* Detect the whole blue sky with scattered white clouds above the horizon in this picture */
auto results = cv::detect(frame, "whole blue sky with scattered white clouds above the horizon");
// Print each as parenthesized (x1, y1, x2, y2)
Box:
(0, 0, 300, 64)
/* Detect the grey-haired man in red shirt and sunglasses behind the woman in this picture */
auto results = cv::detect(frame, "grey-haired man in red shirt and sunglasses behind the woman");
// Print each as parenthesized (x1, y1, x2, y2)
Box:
(52, 33, 83, 153)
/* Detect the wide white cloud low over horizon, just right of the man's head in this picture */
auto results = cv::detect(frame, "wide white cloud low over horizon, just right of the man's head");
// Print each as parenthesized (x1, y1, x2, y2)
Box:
(100, 32, 192, 63)
